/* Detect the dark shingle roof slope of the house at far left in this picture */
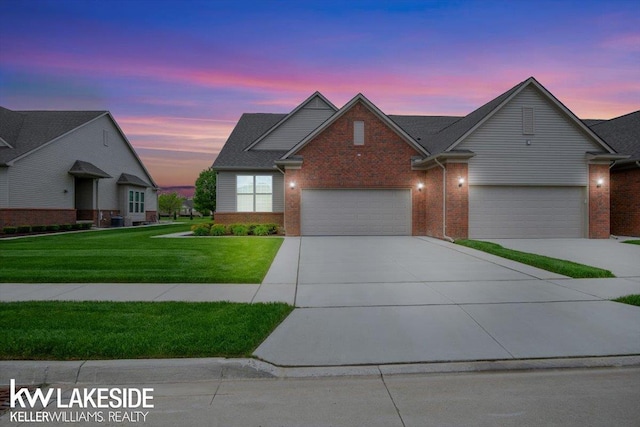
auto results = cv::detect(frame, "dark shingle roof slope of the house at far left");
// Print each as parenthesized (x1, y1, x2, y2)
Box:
(0, 107, 107, 164)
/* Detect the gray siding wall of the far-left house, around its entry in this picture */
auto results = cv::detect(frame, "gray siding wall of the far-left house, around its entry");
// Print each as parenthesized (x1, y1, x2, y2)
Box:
(7, 116, 158, 211)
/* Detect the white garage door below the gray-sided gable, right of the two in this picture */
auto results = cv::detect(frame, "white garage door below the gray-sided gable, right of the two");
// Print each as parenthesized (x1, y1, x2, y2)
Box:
(469, 186, 586, 239)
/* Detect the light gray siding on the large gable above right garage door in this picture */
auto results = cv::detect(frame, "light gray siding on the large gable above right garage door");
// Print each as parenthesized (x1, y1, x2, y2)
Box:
(456, 87, 601, 185)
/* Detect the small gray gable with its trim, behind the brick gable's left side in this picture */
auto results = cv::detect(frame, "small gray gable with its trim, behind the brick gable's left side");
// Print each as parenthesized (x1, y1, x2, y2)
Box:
(245, 92, 338, 151)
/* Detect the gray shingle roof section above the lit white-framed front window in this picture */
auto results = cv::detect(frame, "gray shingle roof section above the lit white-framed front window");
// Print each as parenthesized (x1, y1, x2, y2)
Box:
(213, 113, 287, 170)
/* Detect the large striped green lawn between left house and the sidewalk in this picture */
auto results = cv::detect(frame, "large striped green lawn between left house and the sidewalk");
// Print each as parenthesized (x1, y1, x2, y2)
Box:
(0, 222, 282, 283)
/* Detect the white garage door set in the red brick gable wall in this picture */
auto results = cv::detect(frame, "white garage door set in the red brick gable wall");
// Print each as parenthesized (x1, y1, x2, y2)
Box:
(301, 190, 411, 236)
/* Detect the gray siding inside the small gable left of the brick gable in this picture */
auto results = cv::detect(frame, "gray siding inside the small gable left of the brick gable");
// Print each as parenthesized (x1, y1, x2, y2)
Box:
(252, 97, 334, 151)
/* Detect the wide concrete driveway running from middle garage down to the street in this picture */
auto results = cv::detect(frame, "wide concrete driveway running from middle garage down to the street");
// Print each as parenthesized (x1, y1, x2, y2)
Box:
(254, 237, 640, 366)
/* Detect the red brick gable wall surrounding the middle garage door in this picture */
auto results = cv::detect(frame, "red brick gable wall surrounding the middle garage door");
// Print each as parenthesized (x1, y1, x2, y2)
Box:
(285, 102, 426, 236)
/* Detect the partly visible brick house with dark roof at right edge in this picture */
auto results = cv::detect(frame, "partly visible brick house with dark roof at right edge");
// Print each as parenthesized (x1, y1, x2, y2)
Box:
(587, 111, 640, 236)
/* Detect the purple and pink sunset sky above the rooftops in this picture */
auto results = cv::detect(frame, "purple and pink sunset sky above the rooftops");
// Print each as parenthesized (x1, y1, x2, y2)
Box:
(0, 0, 640, 186)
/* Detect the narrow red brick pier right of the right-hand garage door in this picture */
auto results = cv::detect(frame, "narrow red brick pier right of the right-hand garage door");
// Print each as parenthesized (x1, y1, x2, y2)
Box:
(589, 164, 611, 239)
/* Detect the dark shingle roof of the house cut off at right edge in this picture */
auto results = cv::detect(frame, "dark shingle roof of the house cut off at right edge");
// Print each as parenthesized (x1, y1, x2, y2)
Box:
(590, 110, 640, 163)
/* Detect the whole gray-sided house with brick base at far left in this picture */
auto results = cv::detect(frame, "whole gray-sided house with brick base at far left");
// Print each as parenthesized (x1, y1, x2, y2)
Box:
(0, 107, 158, 228)
